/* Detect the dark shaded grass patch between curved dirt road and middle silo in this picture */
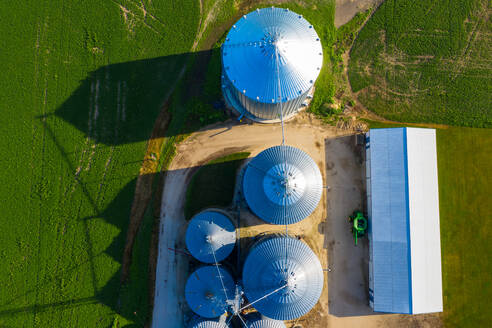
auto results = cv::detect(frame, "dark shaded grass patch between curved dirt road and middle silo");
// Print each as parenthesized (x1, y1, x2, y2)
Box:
(185, 152, 250, 220)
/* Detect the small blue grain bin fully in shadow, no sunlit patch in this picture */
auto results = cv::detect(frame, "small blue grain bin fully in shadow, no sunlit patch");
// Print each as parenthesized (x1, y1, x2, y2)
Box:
(185, 265, 235, 318)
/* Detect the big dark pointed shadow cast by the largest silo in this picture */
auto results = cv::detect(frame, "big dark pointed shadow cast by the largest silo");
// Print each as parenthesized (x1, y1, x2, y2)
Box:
(54, 48, 229, 145)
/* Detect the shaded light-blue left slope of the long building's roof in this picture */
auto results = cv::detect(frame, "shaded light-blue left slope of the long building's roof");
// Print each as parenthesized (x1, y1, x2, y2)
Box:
(368, 128, 412, 313)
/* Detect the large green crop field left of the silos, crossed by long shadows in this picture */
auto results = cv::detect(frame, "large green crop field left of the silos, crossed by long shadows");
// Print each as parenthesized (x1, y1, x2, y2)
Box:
(0, 0, 199, 328)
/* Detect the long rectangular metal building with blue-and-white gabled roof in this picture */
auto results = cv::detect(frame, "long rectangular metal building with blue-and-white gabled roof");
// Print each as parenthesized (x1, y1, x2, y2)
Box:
(366, 128, 443, 314)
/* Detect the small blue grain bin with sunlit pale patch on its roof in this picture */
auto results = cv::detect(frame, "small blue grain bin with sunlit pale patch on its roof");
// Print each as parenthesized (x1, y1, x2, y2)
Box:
(186, 210, 236, 263)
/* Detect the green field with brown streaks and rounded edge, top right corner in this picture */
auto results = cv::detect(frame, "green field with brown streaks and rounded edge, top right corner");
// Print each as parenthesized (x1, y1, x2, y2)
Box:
(349, 0, 492, 127)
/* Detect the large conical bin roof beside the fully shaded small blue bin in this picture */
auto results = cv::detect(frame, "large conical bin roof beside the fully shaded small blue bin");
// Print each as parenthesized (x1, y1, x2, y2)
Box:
(243, 236, 323, 320)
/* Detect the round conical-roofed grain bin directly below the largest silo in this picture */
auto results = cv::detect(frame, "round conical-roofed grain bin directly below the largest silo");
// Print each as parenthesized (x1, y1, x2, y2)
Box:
(243, 145, 323, 224)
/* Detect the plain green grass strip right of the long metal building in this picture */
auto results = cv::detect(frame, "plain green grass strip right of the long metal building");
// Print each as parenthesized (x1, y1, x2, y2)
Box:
(437, 128, 492, 327)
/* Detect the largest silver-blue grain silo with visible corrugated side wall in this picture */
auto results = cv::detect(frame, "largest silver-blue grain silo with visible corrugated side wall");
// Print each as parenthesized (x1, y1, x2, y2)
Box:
(222, 7, 323, 123)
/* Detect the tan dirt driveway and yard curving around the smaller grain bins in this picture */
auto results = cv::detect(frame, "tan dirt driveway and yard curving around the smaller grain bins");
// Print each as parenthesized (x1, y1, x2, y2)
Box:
(152, 113, 440, 328)
